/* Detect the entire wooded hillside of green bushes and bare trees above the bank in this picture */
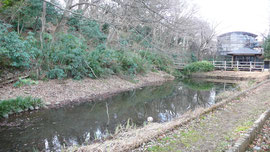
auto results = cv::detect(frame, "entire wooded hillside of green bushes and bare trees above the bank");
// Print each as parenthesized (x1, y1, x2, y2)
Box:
(0, 0, 214, 79)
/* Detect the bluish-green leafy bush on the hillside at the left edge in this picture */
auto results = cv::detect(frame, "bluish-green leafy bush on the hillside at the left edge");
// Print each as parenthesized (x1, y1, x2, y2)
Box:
(0, 20, 40, 68)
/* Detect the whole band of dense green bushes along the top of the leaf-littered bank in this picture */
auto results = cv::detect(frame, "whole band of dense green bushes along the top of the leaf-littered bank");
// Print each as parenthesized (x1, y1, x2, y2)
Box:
(0, 19, 175, 79)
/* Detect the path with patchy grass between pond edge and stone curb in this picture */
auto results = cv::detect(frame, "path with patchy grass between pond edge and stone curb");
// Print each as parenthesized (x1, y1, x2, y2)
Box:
(134, 82, 270, 152)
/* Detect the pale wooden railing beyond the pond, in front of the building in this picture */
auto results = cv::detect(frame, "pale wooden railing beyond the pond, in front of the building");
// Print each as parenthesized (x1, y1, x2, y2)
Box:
(175, 61, 264, 71)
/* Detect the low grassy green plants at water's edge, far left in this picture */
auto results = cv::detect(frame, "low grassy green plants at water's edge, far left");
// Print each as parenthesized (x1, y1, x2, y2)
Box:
(0, 96, 43, 117)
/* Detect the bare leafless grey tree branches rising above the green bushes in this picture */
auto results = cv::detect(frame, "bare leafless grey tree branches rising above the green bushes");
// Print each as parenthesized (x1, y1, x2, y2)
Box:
(43, 0, 215, 61)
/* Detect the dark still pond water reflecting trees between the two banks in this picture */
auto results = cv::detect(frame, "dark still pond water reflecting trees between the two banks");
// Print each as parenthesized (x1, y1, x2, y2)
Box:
(0, 81, 235, 152)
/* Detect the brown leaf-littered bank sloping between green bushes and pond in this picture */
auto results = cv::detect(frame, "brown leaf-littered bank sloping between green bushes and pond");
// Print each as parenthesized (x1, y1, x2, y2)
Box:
(0, 72, 174, 107)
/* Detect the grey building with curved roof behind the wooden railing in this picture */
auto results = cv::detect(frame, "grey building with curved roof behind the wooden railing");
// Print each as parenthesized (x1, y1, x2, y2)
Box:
(218, 31, 262, 62)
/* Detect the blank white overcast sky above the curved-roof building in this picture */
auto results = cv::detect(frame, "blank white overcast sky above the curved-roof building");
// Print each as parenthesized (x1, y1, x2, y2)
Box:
(192, 0, 270, 35)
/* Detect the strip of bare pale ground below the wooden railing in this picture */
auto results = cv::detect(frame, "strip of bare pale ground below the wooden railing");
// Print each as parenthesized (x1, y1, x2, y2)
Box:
(192, 71, 270, 81)
